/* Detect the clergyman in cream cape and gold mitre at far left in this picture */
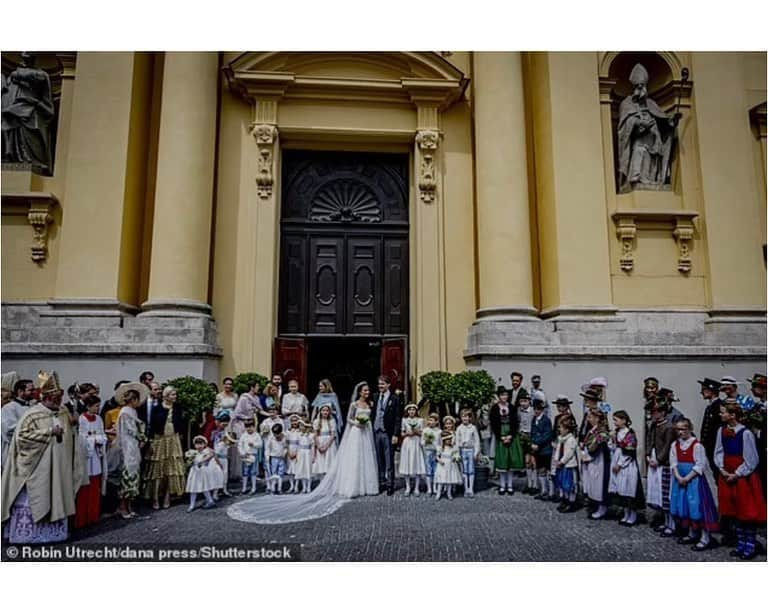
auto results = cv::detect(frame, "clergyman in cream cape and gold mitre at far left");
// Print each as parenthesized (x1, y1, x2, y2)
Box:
(2, 372, 85, 544)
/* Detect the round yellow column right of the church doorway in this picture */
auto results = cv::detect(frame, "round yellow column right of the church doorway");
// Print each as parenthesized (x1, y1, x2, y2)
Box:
(472, 52, 537, 319)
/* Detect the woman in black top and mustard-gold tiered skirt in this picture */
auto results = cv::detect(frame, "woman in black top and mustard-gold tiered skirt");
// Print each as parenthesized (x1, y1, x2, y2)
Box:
(143, 386, 186, 510)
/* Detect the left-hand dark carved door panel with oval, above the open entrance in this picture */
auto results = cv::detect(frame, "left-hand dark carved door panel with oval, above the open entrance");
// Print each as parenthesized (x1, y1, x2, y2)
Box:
(309, 237, 344, 335)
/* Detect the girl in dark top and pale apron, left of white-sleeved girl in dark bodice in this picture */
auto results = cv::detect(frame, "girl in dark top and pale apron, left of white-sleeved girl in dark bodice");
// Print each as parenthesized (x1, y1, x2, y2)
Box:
(581, 409, 611, 520)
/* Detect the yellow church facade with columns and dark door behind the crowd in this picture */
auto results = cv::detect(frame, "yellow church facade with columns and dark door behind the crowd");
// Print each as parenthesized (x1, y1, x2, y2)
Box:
(2, 52, 766, 424)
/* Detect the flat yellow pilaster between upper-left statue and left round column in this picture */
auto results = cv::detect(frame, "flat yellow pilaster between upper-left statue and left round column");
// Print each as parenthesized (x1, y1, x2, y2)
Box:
(51, 53, 152, 315)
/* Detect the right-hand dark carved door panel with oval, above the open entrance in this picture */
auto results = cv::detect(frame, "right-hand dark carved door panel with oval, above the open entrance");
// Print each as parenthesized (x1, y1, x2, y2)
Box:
(346, 237, 382, 335)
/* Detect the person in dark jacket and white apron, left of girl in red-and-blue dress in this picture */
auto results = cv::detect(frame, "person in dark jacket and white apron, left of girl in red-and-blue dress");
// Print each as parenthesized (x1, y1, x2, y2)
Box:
(646, 399, 677, 537)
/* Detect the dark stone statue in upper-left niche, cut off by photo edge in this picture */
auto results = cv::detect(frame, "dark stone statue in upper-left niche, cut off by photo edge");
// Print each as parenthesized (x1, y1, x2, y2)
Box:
(2, 52, 55, 175)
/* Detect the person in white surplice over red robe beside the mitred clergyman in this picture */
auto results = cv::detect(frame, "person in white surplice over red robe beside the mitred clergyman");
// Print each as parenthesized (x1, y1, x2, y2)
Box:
(75, 397, 107, 529)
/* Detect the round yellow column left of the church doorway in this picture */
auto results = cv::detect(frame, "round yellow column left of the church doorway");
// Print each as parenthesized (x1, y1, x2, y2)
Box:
(142, 52, 218, 315)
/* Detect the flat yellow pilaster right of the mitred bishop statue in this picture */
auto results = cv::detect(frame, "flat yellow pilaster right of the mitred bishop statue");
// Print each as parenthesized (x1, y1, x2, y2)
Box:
(691, 52, 766, 318)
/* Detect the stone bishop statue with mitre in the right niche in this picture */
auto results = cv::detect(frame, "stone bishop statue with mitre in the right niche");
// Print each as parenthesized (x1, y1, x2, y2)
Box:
(618, 64, 681, 193)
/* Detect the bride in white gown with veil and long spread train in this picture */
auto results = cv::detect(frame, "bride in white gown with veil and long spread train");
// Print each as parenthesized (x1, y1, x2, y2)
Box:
(227, 382, 379, 524)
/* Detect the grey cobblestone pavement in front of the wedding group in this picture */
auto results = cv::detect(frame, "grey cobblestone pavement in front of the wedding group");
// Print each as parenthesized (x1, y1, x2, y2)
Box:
(73, 490, 765, 565)
